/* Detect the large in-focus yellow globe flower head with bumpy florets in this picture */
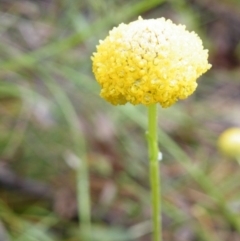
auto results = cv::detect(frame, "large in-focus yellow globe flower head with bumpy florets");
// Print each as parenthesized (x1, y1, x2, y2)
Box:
(92, 18, 211, 107)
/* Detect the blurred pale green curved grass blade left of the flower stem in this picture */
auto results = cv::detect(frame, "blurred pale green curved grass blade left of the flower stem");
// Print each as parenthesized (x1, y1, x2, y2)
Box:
(38, 67, 91, 241)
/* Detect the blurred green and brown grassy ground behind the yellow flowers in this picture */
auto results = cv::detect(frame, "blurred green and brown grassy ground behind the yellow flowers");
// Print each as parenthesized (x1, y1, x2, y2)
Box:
(0, 0, 240, 241)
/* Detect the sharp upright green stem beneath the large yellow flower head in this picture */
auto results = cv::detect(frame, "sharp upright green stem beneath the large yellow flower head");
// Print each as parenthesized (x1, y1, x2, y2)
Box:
(148, 104, 162, 241)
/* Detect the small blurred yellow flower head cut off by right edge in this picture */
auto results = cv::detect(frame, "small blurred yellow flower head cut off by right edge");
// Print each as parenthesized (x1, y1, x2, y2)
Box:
(218, 127, 240, 158)
